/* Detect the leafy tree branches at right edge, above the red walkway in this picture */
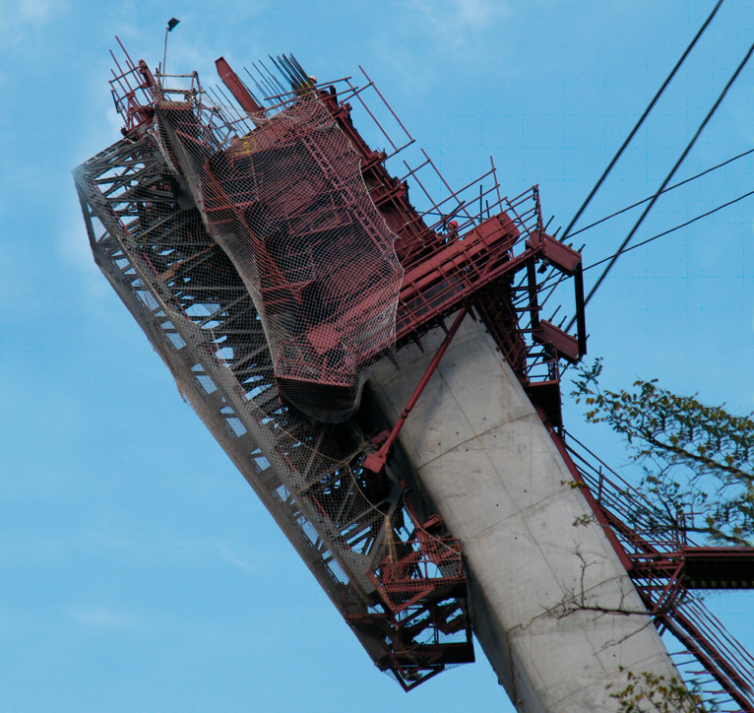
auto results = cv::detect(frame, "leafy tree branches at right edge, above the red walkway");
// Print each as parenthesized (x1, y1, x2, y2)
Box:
(571, 359, 754, 545)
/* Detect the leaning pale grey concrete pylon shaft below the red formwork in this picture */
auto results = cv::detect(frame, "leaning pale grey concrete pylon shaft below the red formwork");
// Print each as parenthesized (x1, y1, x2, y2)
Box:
(370, 317, 681, 713)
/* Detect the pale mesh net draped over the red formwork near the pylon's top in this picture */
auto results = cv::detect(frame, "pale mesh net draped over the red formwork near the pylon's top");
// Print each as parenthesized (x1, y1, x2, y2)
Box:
(156, 90, 403, 423)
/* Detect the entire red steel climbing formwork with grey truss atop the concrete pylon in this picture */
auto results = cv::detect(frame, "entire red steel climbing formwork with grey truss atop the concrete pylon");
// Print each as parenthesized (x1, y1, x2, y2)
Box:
(83, 43, 585, 689)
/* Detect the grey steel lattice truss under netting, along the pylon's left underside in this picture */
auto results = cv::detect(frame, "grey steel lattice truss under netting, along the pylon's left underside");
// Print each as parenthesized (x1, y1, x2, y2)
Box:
(77, 125, 473, 687)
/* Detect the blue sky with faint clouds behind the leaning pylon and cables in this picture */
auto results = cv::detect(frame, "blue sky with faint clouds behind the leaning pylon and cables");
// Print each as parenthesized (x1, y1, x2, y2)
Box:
(0, 0, 754, 713)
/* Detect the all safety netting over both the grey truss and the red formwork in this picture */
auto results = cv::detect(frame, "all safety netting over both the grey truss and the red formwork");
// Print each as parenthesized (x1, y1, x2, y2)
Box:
(76, 55, 473, 688)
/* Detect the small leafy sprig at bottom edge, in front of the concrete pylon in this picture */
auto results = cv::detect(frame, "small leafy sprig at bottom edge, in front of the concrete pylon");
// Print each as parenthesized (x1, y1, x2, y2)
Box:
(610, 671, 716, 713)
